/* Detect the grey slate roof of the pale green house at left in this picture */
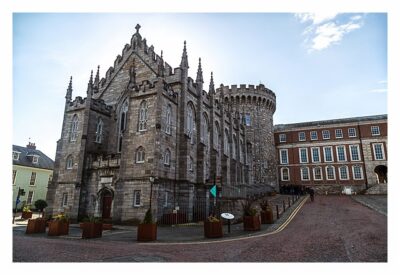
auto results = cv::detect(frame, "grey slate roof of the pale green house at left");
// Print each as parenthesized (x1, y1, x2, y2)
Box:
(13, 145, 54, 170)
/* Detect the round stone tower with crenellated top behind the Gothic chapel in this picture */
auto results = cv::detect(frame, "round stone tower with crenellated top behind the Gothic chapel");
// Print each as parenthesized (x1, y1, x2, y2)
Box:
(217, 84, 278, 189)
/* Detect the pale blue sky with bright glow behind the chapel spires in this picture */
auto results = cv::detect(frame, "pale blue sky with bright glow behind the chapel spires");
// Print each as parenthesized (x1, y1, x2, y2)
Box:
(12, 12, 387, 159)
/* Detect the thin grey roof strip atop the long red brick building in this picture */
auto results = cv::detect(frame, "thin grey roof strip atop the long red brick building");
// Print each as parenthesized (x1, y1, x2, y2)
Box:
(274, 114, 387, 131)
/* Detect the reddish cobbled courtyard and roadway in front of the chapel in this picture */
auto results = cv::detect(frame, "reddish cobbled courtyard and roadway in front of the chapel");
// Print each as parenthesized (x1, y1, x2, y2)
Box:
(13, 196, 387, 262)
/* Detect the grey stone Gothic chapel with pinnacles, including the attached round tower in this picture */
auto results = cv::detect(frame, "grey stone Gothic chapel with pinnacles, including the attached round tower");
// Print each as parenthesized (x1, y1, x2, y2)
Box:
(46, 25, 277, 222)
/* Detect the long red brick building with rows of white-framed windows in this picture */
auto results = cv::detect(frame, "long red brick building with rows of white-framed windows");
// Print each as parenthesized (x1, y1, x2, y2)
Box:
(274, 115, 387, 193)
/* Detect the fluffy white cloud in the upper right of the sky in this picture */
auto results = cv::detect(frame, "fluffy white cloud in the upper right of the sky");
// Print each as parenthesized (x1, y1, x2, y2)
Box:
(295, 12, 363, 52)
